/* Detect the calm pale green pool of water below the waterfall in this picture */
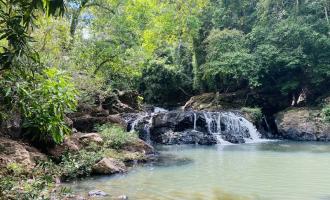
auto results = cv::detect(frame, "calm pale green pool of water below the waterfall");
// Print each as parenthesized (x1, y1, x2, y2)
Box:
(71, 142, 330, 200)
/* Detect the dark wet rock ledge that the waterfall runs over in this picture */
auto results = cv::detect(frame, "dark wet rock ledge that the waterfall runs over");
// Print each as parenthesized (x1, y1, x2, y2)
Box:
(128, 111, 260, 145)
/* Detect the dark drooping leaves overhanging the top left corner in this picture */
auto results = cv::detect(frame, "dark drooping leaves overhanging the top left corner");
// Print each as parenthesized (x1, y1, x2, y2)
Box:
(0, 0, 64, 69)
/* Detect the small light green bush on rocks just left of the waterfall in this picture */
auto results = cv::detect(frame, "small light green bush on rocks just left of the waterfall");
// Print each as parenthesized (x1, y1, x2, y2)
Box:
(97, 124, 138, 149)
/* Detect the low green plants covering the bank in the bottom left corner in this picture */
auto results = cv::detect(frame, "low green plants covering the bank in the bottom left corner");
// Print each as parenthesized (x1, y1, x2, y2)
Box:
(0, 162, 70, 200)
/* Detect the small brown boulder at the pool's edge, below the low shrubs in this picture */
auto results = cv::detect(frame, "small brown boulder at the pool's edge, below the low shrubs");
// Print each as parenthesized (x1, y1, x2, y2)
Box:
(93, 158, 127, 174)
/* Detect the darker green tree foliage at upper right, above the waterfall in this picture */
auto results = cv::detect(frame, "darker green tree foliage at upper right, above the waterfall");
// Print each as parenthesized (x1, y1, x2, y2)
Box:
(195, 0, 330, 106)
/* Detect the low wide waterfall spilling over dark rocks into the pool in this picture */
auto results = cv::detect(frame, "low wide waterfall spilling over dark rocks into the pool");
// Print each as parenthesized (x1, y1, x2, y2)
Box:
(126, 107, 263, 145)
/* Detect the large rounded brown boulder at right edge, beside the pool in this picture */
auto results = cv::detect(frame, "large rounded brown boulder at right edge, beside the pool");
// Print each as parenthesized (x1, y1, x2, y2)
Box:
(276, 107, 330, 141)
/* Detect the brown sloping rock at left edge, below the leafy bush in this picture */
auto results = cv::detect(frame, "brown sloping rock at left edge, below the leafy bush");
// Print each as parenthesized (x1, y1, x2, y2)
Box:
(0, 137, 47, 170)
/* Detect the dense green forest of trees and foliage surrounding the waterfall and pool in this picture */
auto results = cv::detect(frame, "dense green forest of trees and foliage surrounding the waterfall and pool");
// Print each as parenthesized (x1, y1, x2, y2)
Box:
(0, 0, 330, 199)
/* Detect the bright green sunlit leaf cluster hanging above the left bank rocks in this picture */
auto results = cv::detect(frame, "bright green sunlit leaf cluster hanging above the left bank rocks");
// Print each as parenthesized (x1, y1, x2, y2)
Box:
(20, 68, 77, 143)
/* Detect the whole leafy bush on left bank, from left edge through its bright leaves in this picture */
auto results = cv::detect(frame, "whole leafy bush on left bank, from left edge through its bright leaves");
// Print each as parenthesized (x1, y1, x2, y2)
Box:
(0, 68, 77, 143)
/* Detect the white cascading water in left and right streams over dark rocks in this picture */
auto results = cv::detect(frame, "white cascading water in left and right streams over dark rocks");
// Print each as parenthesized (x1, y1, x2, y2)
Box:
(130, 108, 264, 145)
